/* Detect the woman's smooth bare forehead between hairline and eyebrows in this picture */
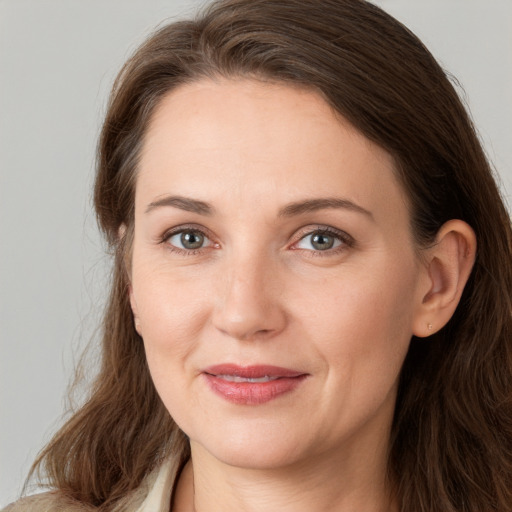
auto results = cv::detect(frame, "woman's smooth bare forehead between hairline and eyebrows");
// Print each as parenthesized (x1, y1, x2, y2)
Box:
(137, 80, 404, 220)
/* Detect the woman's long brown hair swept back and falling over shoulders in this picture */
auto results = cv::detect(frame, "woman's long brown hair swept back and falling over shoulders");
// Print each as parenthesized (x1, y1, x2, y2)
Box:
(31, 0, 512, 512)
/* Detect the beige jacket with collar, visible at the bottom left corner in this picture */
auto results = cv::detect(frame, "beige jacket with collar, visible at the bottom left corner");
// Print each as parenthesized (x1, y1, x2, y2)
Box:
(1, 460, 179, 512)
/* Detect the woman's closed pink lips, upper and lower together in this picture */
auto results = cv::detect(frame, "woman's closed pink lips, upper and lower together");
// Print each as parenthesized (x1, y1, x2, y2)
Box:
(203, 364, 308, 405)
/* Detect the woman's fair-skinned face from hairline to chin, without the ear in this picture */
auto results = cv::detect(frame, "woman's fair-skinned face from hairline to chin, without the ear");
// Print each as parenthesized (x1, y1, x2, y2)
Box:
(131, 80, 426, 468)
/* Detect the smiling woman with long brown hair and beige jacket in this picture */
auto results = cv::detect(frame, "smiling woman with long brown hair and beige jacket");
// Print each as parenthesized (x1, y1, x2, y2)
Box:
(5, 0, 512, 512)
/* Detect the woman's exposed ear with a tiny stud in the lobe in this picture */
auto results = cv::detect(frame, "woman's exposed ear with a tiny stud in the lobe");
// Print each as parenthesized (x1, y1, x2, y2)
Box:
(413, 219, 476, 337)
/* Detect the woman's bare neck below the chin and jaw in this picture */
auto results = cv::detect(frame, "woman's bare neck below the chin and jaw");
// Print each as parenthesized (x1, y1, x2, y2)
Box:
(173, 443, 397, 512)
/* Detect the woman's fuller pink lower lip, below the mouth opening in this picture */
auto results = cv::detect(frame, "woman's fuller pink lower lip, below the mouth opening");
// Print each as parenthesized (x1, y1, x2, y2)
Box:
(203, 373, 306, 405)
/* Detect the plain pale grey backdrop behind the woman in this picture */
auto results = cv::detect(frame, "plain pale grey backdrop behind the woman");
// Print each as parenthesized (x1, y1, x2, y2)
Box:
(0, 0, 512, 507)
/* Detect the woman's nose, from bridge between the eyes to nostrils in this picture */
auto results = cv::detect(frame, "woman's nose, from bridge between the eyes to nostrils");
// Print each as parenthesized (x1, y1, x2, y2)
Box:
(213, 250, 287, 340)
